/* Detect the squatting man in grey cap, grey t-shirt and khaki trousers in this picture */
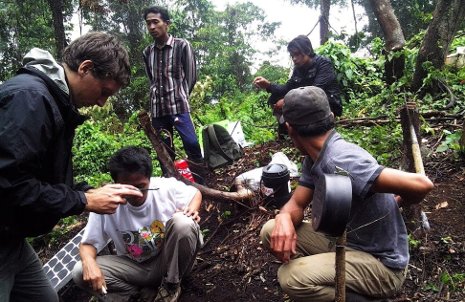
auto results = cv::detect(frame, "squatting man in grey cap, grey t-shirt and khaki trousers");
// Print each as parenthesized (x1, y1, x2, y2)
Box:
(260, 86, 434, 302)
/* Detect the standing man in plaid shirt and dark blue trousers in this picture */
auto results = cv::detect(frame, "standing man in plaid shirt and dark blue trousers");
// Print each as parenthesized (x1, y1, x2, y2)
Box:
(143, 6, 204, 178)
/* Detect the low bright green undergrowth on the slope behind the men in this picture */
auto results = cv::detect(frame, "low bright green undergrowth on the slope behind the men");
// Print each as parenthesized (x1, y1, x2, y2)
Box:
(74, 32, 465, 189)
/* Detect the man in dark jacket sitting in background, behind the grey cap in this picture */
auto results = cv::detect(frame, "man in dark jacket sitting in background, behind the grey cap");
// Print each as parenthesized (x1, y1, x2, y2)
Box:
(253, 35, 342, 138)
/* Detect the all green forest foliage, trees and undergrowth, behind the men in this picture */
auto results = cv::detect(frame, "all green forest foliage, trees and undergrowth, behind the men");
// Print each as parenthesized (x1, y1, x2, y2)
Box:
(0, 0, 465, 185)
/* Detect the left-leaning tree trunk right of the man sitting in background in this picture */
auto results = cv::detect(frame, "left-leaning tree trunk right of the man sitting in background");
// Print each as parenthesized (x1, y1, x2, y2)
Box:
(369, 0, 405, 84)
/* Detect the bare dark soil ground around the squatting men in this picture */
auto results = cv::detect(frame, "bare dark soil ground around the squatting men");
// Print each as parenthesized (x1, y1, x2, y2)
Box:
(40, 132, 465, 302)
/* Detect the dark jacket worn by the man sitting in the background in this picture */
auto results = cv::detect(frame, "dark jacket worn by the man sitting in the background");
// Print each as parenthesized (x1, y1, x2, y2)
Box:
(267, 55, 342, 116)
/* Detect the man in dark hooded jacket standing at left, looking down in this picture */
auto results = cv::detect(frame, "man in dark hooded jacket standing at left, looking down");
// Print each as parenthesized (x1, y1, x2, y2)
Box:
(0, 32, 142, 302)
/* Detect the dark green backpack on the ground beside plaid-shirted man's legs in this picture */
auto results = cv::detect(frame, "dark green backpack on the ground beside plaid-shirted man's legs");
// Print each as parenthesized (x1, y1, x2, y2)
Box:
(202, 124, 244, 169)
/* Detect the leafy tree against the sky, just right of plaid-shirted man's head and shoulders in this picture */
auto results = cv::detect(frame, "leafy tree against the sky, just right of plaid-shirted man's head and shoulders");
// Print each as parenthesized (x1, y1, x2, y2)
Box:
(185, 2, 279, 98)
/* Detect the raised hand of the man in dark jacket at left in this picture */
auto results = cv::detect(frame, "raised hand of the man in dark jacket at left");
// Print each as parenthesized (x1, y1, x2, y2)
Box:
(85, 184, 142, 214)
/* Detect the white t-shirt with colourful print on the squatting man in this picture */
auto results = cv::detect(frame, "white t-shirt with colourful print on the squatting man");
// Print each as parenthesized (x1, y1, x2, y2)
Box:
(81, 177, 197, 262)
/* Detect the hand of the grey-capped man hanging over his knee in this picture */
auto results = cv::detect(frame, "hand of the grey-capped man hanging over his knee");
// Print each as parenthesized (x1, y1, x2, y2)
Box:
(270, 213, 297, 263)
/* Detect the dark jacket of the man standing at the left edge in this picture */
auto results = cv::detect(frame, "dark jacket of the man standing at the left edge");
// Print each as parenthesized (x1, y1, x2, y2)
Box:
(0, 68, 86, 241)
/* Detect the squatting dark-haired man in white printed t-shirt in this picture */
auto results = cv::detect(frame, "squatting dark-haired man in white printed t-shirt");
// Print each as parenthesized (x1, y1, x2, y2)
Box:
(73, 147, 202, 302)
